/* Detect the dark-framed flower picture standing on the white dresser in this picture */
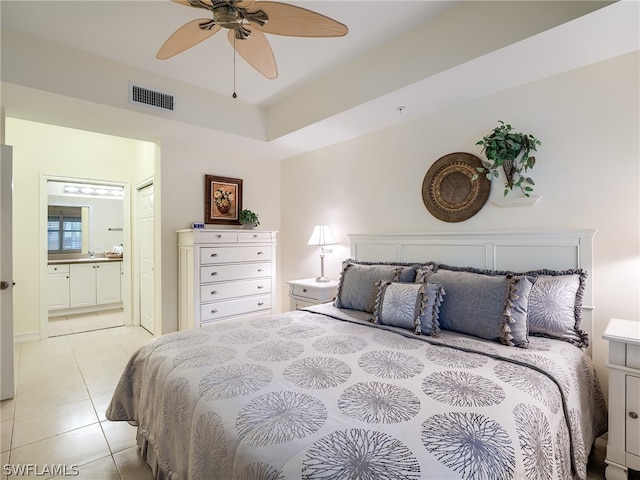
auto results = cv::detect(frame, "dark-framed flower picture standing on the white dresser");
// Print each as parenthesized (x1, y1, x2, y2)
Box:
(204, 175, 242, 225)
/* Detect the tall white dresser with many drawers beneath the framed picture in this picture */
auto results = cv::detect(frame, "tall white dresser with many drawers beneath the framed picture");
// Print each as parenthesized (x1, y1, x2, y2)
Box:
(178, 229, 276, 330)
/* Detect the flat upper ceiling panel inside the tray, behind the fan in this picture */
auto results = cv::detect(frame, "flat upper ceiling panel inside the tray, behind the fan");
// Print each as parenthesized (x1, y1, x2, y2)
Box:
(2, 0, 458, 104)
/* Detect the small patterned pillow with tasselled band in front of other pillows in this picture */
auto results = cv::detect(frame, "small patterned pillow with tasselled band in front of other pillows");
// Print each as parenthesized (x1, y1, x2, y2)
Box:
(373, 280, 444, 336)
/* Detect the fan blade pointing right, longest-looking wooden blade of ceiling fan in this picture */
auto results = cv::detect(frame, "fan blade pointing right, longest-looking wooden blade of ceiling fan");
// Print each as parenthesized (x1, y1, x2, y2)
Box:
(247, 2, 349, 37)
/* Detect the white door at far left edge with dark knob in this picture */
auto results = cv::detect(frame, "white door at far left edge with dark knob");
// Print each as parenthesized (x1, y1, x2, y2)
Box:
(0, 145, 14, 400)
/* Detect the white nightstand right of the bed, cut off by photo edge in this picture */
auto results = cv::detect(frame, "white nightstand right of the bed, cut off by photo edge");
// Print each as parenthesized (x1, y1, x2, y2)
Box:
(602, 318, 640, 480)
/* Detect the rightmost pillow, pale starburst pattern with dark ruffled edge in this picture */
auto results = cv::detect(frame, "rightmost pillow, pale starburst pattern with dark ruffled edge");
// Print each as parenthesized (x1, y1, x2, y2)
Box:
(526, 270, 589, 347)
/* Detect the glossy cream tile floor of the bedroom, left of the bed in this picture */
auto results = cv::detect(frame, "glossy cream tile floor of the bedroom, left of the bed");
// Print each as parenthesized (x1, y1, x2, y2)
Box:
(0, 320, 624, 480)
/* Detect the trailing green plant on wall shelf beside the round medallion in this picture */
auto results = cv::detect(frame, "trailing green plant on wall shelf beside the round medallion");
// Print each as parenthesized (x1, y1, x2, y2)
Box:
(473, 120, 541, 197)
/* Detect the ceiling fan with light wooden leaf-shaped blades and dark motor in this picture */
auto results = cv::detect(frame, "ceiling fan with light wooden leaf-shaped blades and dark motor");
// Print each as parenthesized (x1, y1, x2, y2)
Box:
(156, 0, 349, 79)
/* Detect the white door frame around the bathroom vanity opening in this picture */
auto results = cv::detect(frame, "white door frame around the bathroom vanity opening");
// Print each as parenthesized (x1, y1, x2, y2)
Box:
(39, 174, 132, 340)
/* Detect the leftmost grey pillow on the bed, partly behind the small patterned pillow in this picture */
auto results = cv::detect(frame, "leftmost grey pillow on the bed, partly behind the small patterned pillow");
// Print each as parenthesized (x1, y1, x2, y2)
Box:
(334, 259, 417, 313)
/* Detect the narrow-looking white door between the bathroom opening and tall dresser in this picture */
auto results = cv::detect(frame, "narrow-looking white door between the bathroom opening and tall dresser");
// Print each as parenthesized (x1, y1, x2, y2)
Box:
(138, 185, 155, 334)
